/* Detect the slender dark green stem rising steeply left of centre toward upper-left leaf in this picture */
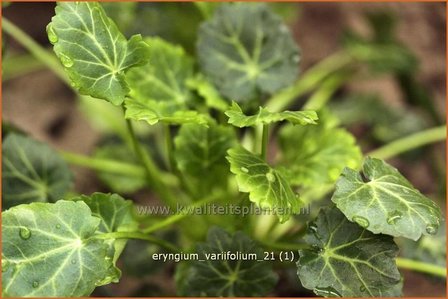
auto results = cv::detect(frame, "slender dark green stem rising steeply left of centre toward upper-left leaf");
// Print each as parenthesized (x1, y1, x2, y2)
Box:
(123, 106, 177, 207)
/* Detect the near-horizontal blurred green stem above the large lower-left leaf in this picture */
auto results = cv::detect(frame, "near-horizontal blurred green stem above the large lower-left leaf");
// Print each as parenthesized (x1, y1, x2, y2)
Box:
(59, 151, 178, 186)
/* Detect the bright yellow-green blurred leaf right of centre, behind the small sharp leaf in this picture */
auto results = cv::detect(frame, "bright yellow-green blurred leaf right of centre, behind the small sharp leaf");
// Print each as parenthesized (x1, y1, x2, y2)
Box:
(278, 111, 362, 187)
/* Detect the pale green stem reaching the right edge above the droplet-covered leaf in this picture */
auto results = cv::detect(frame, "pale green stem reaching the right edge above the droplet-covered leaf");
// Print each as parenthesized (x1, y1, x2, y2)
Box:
(367, 125, 446, 159)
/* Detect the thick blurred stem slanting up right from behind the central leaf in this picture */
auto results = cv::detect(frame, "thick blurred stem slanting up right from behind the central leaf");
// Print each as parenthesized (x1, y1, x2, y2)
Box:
(266, 52, 353, 111)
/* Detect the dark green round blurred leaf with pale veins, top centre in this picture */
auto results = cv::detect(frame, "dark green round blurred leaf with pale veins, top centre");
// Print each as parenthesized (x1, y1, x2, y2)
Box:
(197, 3, 299, 102)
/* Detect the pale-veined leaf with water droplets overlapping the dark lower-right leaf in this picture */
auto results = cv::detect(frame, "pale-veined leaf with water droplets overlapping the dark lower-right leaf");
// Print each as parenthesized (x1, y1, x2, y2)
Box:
(331, 157, 442, 240)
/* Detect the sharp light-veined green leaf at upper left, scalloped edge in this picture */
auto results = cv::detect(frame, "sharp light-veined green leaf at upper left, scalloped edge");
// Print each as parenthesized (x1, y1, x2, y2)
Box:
(47, 2, 148, 105)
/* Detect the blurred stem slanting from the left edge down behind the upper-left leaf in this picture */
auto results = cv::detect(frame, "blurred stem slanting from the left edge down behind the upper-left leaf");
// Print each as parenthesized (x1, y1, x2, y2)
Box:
(2, 18, 72, 88)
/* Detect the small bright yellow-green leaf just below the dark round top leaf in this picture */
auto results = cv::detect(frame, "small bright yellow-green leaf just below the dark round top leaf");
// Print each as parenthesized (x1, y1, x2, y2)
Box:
(187, 74, 229, 111)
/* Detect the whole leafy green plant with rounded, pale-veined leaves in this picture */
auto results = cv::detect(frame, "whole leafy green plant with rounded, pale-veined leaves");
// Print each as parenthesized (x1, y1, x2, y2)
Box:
(2, 2, 444, 297)
